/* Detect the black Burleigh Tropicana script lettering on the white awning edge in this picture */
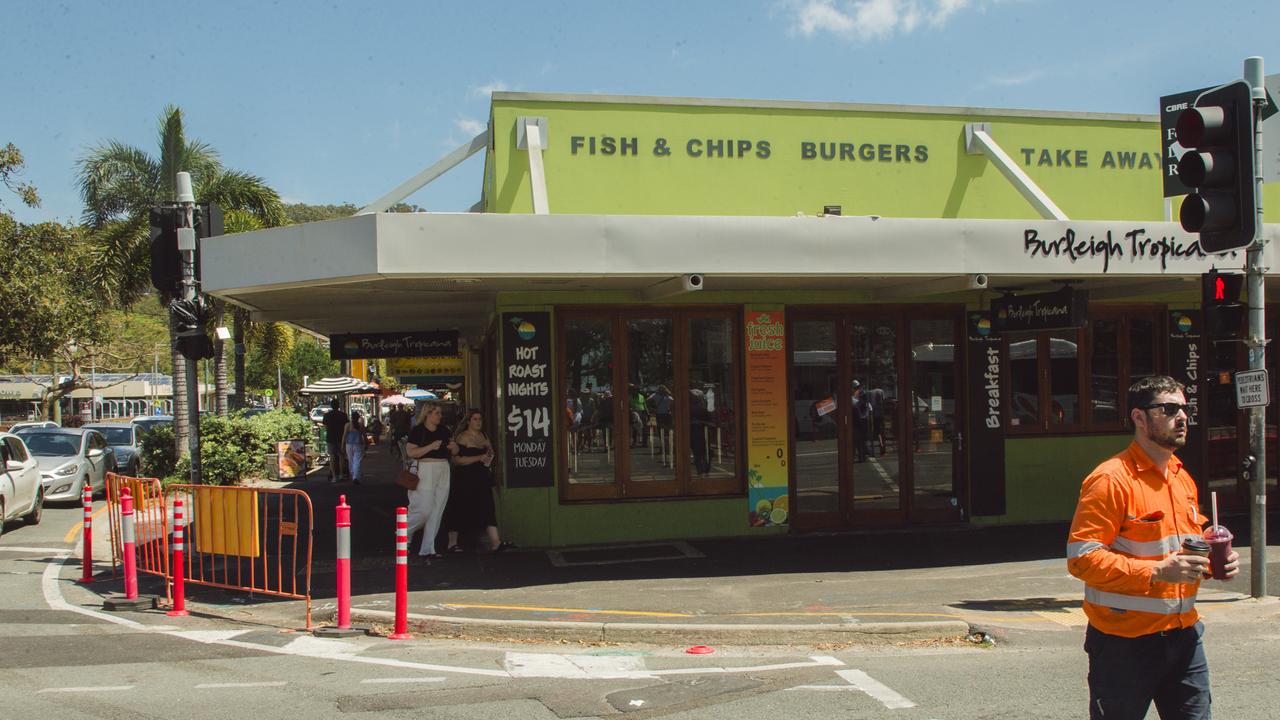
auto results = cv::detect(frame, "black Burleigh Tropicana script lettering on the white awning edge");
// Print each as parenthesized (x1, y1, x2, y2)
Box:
(1023, 228, 1235, 273)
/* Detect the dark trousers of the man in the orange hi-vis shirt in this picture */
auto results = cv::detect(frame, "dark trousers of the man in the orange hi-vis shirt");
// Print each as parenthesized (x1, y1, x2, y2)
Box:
(1084, 623, 1211, 720)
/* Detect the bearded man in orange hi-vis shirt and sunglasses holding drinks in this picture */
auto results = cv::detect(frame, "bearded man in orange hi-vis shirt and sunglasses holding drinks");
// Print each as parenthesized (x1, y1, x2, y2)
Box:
(1066, 377, 1239, 720)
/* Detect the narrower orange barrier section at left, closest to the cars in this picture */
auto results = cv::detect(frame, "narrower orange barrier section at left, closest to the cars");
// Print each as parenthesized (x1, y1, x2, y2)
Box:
(106, 473, 173, 603)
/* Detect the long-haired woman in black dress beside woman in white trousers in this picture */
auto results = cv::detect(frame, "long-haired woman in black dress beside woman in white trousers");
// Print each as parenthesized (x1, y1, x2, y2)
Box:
(444, 410, 515, 552)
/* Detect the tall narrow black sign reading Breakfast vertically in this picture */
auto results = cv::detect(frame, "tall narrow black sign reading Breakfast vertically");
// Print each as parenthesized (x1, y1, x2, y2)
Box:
(965, 311, 1005, 515)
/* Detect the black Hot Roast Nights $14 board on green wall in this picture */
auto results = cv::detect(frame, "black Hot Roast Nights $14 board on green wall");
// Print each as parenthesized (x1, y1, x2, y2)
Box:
(502, 313, 556, 488)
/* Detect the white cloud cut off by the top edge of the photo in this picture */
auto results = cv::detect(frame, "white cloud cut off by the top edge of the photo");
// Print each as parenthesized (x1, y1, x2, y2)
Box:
(791, 0, 974, 41)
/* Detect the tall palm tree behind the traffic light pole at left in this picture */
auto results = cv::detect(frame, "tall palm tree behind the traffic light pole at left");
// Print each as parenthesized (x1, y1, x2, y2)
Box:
(79, 105, 284, 455)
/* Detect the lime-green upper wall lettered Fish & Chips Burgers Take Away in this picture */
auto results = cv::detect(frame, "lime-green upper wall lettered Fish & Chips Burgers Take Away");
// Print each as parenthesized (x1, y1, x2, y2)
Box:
(485, 97, 1280, 220)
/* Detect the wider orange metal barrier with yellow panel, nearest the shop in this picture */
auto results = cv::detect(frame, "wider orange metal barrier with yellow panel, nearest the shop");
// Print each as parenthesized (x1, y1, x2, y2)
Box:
(169, 486, 315, 629)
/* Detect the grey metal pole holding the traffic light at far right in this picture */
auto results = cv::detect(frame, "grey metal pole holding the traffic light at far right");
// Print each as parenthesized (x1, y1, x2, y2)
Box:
(1244, 56, 1267, 598)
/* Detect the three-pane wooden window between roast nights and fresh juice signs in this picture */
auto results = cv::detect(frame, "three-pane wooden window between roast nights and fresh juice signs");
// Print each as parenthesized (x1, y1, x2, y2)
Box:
(557, 307, 742, 500)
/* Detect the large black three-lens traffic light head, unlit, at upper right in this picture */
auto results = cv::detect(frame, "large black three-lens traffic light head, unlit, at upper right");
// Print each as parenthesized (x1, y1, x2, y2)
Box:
(1175, 81, 1257, 252)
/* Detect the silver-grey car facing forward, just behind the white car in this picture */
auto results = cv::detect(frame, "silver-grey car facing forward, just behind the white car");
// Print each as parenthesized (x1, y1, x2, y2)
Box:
(22, 428, 115, 501)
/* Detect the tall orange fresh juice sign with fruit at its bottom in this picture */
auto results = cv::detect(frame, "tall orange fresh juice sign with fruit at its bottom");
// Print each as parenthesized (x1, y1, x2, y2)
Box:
(744, 309, 788, 525)
